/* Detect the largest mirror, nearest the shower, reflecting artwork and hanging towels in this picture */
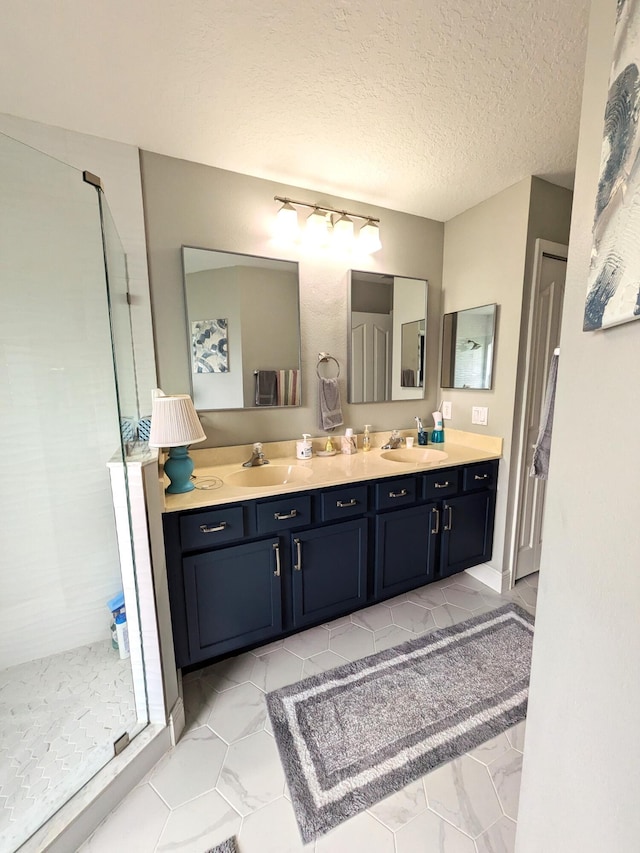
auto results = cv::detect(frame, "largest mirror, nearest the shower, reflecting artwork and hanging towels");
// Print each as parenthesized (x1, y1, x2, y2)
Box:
(182, 246, 301, 411)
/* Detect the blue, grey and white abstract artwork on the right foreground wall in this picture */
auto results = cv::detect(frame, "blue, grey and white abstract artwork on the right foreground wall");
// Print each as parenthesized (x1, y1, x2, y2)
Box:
(583, 0, 640, 331)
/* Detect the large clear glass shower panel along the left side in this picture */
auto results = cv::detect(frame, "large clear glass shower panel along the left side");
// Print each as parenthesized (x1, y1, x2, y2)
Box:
(0, 134, 146, 850)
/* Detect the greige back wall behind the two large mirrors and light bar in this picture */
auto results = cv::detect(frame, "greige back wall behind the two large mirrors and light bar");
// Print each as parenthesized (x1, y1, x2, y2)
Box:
(141, 151, 444, 447)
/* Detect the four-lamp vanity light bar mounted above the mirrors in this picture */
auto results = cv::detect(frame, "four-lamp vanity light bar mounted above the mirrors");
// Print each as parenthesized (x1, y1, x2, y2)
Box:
(274, 195, 382, 254)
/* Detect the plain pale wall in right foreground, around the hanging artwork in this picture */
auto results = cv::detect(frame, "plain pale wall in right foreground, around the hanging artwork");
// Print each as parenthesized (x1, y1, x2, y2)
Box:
(516, 0, 640, 853)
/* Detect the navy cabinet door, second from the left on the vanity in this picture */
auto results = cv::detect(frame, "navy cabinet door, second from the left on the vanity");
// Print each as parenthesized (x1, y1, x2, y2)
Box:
(291, 518, 367, 628)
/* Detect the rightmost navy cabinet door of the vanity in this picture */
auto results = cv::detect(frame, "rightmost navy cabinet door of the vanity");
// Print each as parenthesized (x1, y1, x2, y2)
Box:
(440, 490, 495, 577)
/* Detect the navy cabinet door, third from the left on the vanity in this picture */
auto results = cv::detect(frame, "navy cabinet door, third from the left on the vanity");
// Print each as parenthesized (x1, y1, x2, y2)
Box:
(375, 504, 440, 598)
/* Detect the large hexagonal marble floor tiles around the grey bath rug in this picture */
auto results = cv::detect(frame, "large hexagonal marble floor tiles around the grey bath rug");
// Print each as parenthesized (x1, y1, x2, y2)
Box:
(81, 573, 537, 853)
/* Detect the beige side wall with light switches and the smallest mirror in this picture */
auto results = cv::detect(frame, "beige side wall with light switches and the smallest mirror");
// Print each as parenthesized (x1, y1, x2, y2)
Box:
(439, 178, 571, 586)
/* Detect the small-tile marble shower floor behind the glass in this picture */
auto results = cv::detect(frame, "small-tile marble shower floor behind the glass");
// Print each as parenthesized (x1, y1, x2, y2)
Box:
(0, 640, 137, 853)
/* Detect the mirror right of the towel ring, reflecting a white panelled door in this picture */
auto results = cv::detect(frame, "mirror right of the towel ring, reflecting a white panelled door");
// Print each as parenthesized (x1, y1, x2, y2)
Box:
(347, 270, 428, 403)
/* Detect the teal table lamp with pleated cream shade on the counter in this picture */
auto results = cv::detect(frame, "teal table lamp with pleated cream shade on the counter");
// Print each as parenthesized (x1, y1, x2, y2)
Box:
(149, 389, 207, 495)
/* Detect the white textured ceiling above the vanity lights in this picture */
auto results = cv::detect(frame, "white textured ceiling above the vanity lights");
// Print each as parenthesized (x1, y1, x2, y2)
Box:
(0, 0, 589, 220)
